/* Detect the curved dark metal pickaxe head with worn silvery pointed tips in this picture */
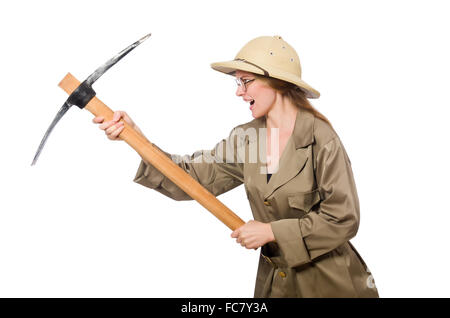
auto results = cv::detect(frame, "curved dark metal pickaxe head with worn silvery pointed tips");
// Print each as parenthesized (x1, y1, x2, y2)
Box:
(31, 33, 151, 165)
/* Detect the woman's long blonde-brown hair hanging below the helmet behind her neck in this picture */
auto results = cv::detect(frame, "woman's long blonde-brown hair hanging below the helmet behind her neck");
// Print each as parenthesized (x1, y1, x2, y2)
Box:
(253, 74, 333, 128)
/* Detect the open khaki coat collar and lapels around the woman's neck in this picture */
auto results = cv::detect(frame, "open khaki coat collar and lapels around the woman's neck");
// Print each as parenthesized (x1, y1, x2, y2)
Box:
(250, 109, 315, 199)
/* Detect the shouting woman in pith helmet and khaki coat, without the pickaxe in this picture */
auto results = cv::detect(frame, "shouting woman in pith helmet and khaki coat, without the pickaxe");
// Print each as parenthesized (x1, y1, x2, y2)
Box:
(94, 36, 378, 297)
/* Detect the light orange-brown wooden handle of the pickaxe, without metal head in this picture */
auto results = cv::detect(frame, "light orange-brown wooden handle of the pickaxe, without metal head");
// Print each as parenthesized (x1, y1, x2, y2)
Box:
(58, 73, 245, 231)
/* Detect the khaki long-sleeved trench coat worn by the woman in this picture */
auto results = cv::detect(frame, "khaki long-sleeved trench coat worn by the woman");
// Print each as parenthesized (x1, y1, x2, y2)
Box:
(134, 110, 379, 297)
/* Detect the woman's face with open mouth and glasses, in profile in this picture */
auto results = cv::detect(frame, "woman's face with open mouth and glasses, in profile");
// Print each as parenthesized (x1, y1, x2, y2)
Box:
(235, 70, 277, 118)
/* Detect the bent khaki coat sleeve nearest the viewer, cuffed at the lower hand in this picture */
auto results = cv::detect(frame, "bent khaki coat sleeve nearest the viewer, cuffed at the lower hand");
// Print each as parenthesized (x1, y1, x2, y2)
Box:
(271, 137, 359, 267)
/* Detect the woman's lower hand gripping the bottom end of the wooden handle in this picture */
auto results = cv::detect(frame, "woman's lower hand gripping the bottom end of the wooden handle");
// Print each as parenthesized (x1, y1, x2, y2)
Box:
(231, 220, 275, 249)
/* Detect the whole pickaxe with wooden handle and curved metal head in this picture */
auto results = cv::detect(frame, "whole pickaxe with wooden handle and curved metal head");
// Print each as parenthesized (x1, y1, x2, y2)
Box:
(31, 34, 244, 231)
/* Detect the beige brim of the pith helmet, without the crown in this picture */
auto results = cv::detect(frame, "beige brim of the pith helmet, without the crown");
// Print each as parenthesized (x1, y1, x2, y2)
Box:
(211, 60, 320, 98)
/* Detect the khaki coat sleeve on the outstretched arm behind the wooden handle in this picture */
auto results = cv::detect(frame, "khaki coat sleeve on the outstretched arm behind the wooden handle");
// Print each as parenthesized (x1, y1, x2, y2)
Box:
(133, 127, 244, 201)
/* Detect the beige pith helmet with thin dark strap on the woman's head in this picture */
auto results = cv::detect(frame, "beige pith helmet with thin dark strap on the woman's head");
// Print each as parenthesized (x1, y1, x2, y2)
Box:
(211, 35, 320, 98)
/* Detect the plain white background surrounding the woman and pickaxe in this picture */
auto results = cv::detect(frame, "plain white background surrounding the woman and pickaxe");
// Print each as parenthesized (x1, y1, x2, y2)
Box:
(0, 0, 450, 297)
